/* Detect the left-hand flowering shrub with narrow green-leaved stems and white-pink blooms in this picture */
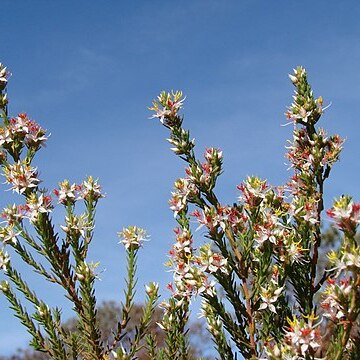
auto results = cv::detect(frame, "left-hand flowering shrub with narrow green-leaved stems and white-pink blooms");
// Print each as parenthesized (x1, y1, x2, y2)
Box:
(0, 64, 158, 360)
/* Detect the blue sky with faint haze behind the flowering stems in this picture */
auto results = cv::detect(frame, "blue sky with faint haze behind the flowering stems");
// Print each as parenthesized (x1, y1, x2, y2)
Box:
(0, 0, 360, 354)
